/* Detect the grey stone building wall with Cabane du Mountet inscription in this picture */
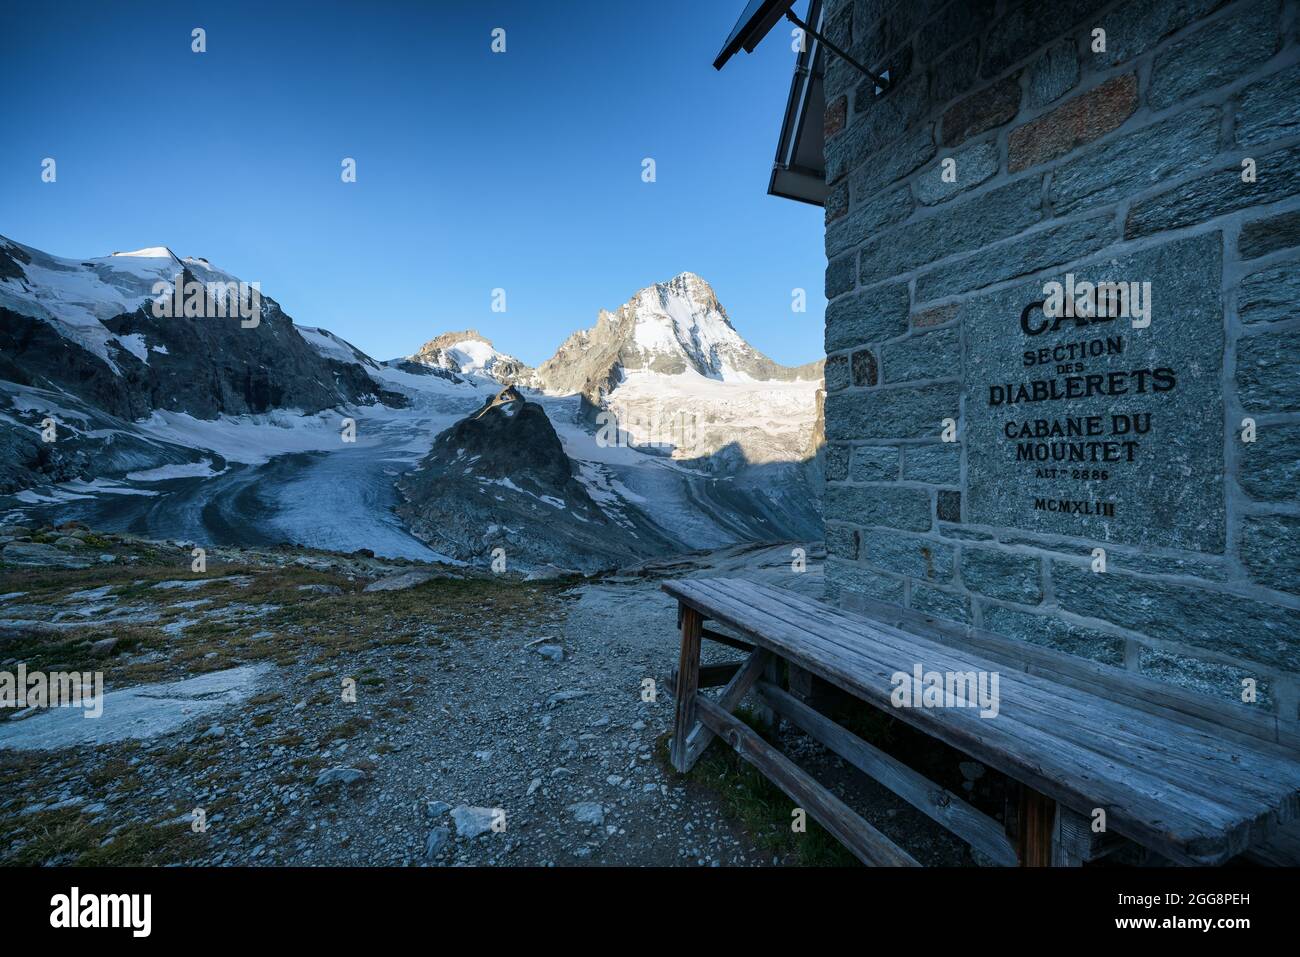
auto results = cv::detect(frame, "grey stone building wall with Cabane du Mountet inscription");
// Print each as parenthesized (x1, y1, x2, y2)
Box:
(824, 0, 1300, 718)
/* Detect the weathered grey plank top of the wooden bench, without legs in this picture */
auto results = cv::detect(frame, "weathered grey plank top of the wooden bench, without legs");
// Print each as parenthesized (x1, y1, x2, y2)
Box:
(664, 579, 1300, 863)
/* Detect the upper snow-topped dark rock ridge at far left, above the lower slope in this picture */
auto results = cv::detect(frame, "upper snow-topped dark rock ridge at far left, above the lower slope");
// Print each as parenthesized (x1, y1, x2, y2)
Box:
(0, 238, 403, 419)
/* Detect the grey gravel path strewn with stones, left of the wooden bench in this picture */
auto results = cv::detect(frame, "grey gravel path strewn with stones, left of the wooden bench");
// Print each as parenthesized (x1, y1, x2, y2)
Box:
(285, 583, 764, 866)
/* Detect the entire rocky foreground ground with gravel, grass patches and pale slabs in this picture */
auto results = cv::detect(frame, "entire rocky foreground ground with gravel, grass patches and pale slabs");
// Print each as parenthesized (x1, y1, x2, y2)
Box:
(0, 527, 996, 866)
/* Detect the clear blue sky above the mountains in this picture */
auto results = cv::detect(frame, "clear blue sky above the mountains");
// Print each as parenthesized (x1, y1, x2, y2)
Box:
(0, 0, 826, 364)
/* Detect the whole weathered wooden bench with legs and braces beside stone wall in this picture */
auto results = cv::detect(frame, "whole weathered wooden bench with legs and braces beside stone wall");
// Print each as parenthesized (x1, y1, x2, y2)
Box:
(663, 579, 1300, 866)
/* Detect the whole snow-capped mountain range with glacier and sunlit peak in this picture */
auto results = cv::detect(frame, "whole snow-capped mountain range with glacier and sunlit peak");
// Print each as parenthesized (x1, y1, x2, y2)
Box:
(0, 237, 822, 570)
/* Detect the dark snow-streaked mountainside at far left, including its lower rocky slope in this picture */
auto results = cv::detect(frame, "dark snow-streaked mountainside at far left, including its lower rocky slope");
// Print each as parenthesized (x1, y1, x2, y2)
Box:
(0, 237, 408, 499)
